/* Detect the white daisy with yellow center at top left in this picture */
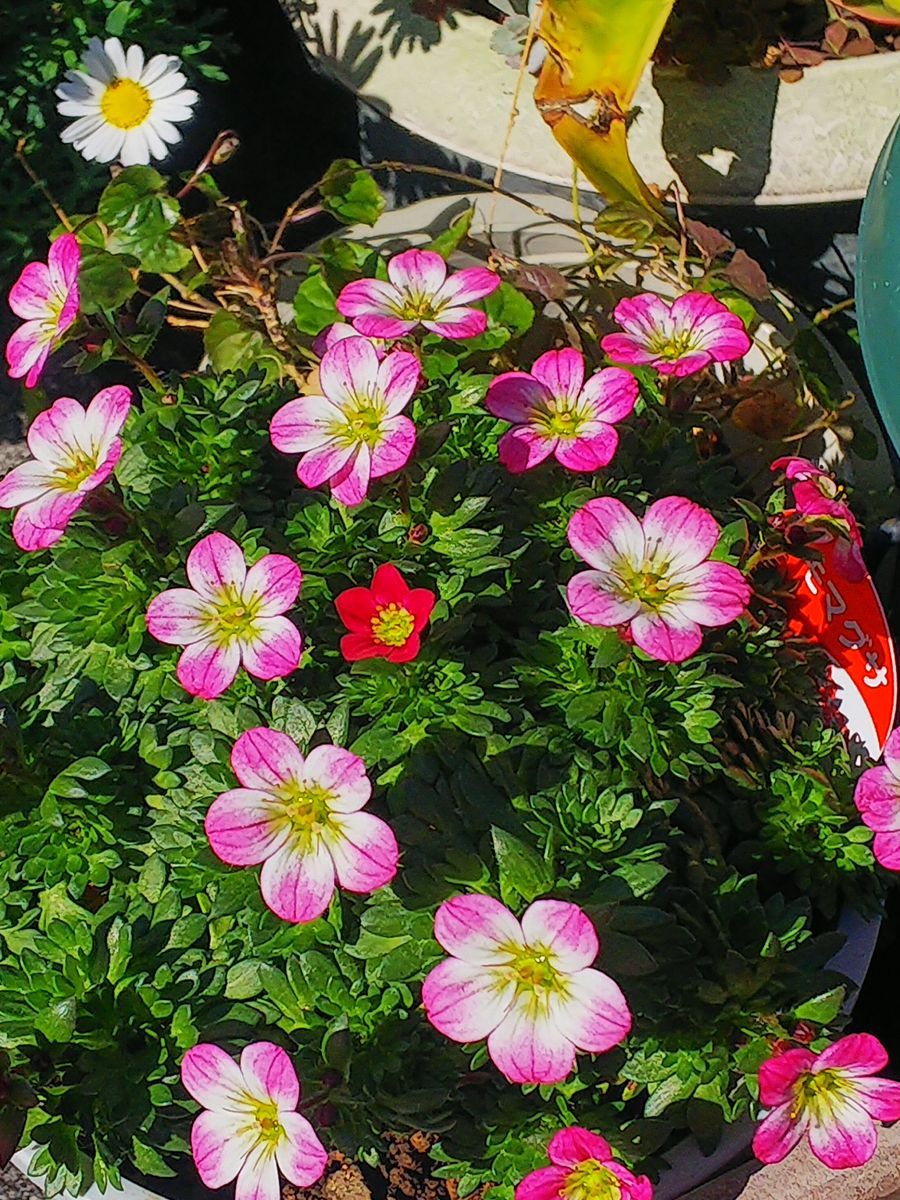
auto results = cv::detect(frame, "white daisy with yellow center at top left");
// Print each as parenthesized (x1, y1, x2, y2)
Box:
(56, 37, 198, 167)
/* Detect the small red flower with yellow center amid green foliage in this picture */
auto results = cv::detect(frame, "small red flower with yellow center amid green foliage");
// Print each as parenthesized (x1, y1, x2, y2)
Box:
(335, 563, 437, 662)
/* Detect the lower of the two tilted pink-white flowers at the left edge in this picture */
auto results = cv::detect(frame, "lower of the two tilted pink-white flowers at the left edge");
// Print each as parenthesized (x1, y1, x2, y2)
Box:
(0, 385, 131, 550)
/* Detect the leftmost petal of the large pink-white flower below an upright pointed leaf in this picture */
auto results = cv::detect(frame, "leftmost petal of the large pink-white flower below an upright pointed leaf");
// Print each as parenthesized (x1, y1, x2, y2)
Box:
(422, 959, 516, 1042)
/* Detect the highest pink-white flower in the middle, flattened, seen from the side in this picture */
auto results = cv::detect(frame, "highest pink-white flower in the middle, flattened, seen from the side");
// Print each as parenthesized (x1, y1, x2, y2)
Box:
(337, 250, 500, 338)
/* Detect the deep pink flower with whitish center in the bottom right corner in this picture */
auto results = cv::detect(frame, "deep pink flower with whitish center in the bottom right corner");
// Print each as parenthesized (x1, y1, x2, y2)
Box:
(754, 1033, 900, 1170)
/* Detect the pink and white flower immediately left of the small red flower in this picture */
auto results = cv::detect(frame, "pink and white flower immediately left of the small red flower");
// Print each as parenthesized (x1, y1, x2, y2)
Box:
(146, 533, 302, 700)
